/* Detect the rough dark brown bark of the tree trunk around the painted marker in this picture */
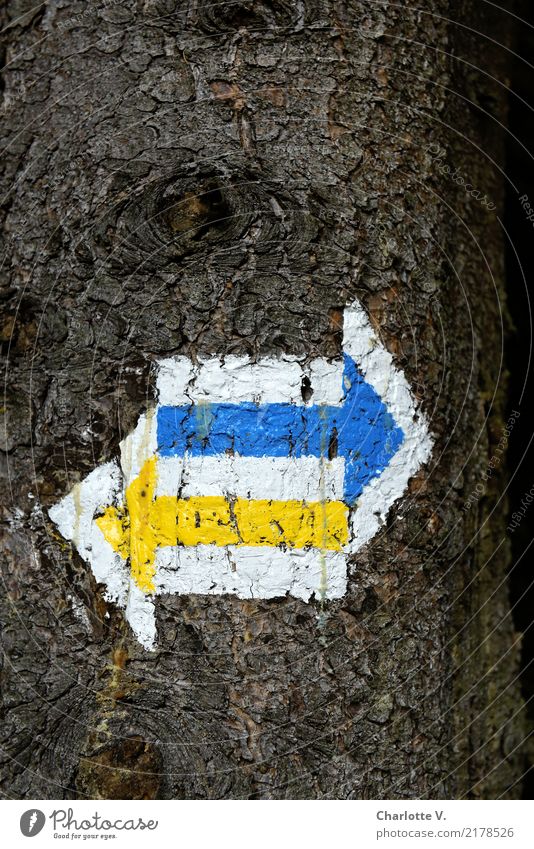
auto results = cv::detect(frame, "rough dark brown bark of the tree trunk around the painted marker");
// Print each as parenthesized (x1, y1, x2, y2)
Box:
(1, 0, 523, 799)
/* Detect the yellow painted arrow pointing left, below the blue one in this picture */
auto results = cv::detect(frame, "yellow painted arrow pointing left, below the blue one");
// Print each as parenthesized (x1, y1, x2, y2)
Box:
(96, 457, 348, 593)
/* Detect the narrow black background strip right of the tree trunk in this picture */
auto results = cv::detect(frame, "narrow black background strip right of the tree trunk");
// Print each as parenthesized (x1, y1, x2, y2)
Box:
(504, 0, 534, 799)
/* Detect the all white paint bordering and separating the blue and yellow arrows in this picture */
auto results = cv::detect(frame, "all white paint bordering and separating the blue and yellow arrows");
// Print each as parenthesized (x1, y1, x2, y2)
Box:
(50, 304, 432, 649)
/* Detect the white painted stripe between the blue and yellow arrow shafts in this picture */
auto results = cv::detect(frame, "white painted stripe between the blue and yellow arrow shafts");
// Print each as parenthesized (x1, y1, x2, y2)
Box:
(156, 454, 345, 501)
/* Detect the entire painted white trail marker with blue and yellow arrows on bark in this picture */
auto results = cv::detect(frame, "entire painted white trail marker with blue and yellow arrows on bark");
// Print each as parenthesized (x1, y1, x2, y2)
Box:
(50, 305, 431, 649)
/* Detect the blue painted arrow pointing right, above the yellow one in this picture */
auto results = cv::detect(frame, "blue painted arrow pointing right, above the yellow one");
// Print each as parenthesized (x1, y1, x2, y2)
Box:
(158, 354, 404, 505)
